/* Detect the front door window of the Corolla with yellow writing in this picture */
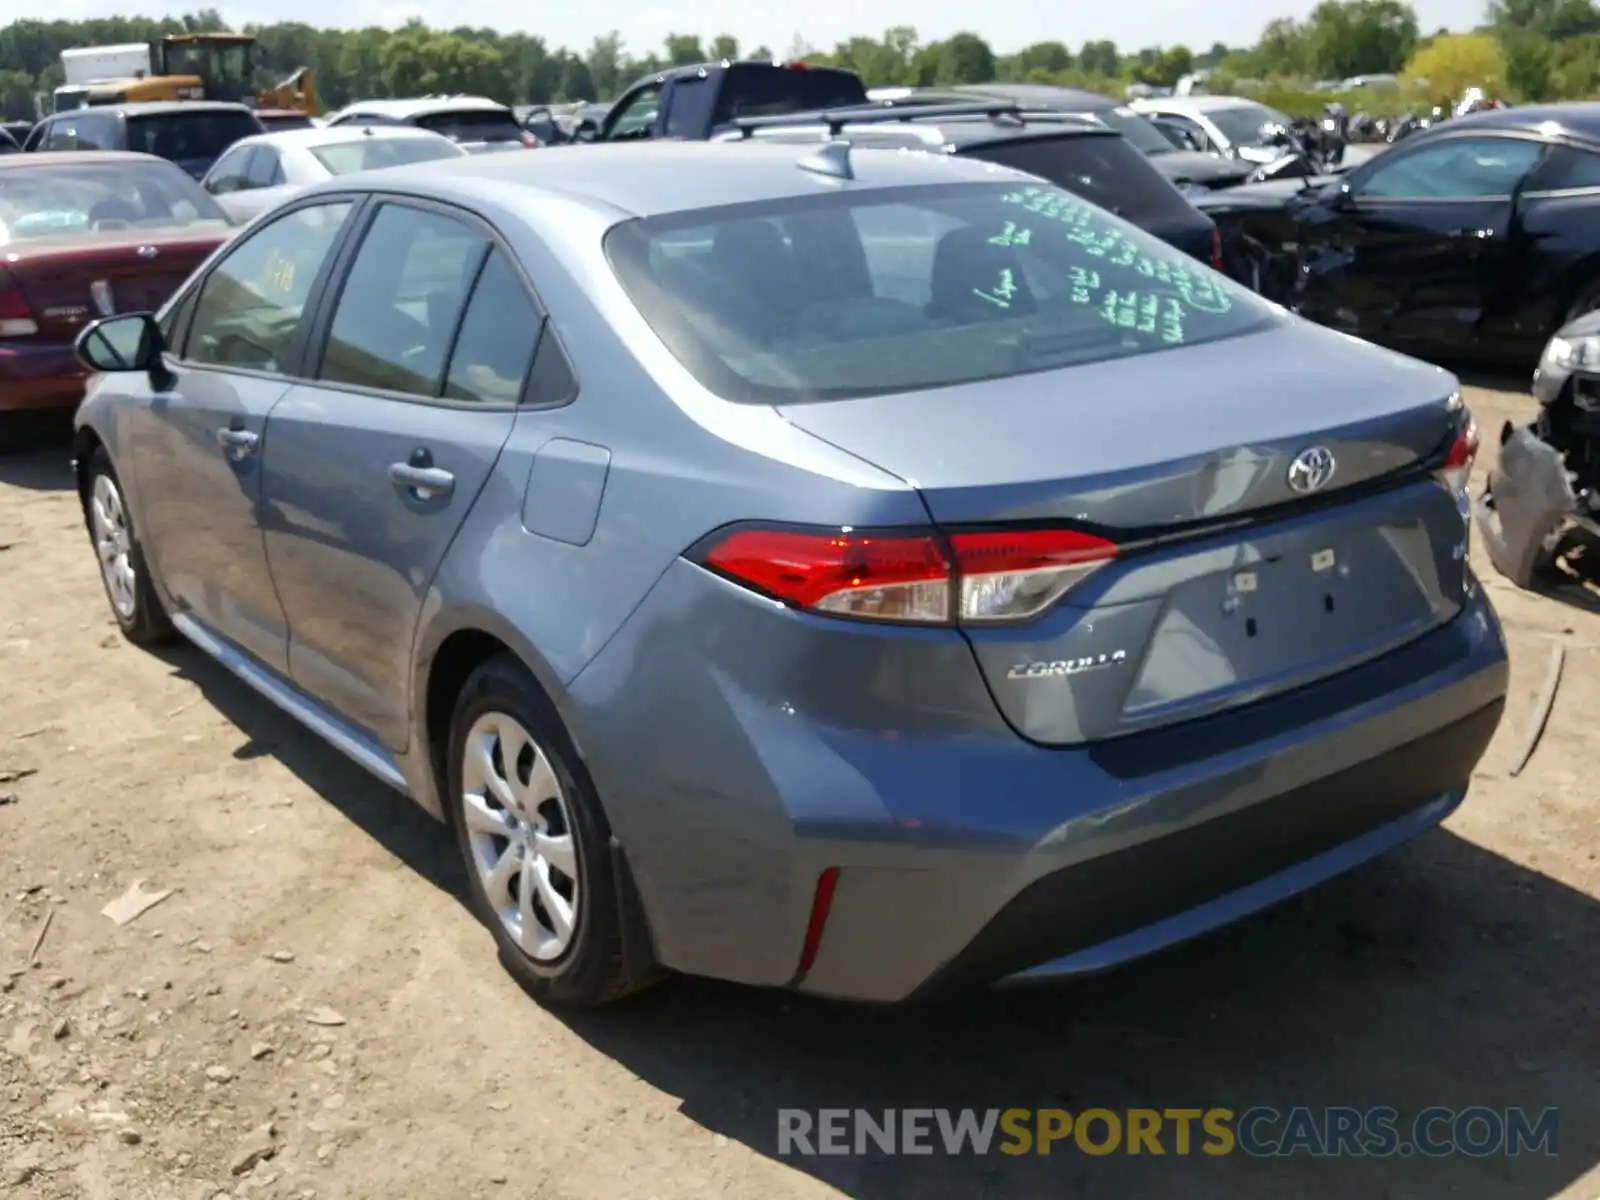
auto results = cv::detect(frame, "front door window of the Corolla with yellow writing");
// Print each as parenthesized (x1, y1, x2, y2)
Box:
(184, 200, 354, 373)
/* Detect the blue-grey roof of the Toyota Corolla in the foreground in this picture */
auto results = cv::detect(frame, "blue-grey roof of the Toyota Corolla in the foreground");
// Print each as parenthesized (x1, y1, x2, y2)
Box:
(314, 141, 1034, 219)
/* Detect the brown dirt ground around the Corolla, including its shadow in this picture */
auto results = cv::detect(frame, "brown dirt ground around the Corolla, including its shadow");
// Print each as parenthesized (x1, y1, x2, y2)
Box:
(0, 380, 1600, 1200)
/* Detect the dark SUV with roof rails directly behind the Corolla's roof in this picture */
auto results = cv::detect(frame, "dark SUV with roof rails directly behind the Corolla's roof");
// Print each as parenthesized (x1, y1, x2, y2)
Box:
(717, 101, 1221, 269)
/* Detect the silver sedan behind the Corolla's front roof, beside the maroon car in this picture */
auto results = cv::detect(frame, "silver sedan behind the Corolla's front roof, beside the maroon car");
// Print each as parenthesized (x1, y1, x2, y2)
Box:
(200, 125, 467, 224)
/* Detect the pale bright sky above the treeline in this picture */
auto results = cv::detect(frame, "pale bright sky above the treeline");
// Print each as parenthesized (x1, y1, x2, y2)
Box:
(9, 0, 1485, 53)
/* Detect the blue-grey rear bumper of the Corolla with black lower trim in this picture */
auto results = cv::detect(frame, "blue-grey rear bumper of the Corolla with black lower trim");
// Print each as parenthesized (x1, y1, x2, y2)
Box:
(568, 563, 1507, 1002)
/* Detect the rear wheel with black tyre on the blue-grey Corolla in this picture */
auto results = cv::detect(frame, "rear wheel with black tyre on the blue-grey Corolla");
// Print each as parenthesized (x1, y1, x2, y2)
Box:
(445, 656, 650, 1008)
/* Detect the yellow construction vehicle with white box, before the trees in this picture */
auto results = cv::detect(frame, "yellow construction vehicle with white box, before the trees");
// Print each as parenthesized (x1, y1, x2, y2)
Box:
(54, 34, 317, 117)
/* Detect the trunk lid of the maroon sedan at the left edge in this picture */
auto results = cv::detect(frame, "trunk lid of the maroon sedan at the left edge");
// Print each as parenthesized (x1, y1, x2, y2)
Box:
(5, 226, 234, 341)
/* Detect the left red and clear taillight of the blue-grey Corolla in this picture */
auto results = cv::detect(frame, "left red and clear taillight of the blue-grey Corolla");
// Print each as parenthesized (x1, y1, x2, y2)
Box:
(704, 530, 1117, 624)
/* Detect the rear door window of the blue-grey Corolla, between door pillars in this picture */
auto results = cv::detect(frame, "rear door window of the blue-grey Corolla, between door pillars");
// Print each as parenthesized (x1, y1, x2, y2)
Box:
(320, 205, 488, 398)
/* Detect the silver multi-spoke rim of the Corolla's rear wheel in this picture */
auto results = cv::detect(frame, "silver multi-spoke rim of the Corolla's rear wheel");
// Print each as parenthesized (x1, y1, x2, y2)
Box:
(461, 712, 581, 962)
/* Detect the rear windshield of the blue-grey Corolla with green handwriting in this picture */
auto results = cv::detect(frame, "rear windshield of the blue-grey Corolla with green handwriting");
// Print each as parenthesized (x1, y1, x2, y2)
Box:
(605, 182, 1275, 403)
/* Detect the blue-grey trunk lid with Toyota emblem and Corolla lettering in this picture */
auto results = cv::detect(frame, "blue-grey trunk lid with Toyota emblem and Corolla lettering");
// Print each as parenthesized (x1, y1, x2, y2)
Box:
(782, 322, 1466, 744)
